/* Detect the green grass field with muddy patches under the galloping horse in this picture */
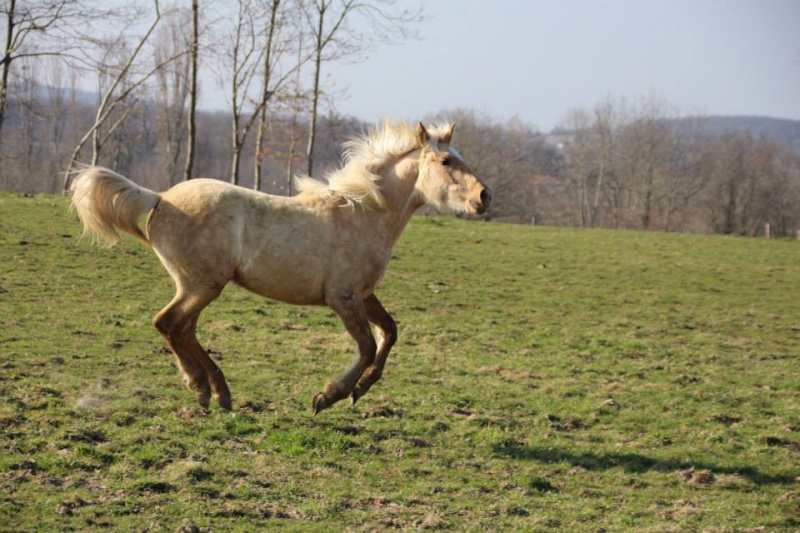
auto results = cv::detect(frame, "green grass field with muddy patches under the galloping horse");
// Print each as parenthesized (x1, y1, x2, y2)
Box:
(0, 193, 800, 532)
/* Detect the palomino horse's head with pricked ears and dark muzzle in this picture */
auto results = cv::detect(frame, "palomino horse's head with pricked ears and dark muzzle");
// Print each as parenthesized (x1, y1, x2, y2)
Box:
(416, 122, 492, 215)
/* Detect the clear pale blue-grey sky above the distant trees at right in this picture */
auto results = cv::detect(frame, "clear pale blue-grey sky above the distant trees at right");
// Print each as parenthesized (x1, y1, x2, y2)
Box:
(200, 0, 800, 131)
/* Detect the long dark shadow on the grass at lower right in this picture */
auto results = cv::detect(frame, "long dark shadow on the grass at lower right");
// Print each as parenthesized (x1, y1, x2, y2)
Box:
(492, 443, 795, 485)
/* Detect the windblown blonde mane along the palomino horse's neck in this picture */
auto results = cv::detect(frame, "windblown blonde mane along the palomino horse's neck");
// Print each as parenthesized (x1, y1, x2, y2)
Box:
(295, 120, 449, 210)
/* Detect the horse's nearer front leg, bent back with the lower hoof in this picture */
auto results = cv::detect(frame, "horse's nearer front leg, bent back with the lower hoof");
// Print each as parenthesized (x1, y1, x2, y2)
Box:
(312, 292, 377, 415)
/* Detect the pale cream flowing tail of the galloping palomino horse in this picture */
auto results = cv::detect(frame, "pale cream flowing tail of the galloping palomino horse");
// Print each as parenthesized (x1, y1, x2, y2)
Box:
(70, 167, 161, 247)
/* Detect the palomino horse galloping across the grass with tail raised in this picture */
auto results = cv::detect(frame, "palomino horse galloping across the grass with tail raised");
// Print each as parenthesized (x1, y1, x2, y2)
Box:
(72, 121, 492, 414)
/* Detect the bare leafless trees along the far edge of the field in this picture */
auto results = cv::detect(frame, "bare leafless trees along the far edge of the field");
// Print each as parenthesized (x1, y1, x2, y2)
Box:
(0, 0, 800, 236)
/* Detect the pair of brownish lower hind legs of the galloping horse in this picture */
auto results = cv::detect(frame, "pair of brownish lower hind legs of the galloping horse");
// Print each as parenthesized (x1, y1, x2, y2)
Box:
(153, 289, 231, 409)
